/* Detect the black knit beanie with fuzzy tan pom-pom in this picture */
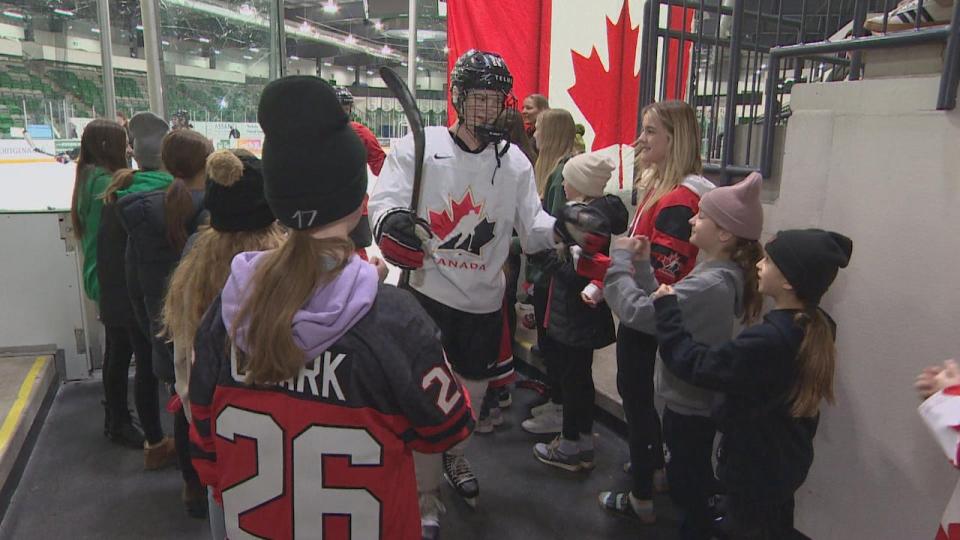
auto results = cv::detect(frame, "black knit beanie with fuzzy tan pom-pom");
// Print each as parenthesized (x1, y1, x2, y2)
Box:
(203, 150, 276, 232)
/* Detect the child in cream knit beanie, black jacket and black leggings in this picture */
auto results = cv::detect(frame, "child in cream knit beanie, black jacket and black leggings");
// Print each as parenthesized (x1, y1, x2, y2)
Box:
(531, 154, 628, 471)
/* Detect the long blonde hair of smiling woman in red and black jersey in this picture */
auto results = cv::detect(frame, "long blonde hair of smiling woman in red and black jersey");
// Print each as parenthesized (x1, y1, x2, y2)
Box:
(634, 100, 703, 212)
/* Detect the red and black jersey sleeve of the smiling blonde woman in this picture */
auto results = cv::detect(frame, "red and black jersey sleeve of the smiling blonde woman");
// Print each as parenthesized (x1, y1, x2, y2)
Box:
(650, 188, 700, 285)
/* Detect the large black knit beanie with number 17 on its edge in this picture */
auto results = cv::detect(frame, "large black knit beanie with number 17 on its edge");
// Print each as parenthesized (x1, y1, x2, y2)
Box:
(257, 75, 367, 230)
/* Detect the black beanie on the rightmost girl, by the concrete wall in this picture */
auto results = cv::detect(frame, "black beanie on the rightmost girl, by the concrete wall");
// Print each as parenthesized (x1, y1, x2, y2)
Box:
(764, 229, 853, 305)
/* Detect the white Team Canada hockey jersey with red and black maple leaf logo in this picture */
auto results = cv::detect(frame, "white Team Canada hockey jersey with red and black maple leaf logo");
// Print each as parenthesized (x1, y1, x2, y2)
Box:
(368, 126, 555, 313)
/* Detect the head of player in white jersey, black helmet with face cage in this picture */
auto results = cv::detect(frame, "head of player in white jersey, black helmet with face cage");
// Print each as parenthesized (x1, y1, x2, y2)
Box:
(450, 49, 516, 146)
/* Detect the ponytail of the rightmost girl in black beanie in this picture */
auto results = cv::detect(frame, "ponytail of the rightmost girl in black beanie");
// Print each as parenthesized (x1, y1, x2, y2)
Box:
(790, 306, 837, 418)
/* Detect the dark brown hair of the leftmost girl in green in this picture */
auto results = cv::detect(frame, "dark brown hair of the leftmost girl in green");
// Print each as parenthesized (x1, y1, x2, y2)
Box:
(70, 118, 127, 238)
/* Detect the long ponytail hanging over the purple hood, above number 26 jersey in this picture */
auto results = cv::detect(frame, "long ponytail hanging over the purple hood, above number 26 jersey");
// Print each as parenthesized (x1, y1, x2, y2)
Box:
(230, 231, 354, 384)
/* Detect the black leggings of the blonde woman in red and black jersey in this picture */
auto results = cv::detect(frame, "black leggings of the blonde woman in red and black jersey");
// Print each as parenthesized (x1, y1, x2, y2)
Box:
(617, 324, 663, 499)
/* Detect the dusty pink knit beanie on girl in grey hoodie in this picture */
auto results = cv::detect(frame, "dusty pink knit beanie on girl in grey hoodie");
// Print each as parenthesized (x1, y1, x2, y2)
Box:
(700, 173, 763, 240)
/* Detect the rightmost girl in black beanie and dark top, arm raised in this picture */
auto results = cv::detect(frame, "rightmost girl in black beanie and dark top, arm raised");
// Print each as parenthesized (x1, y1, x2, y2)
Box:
(654, 229, 853, 539)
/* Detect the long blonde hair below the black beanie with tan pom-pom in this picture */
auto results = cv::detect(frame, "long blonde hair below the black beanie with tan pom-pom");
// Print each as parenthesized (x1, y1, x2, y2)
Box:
(159, 223, 284, 354)
